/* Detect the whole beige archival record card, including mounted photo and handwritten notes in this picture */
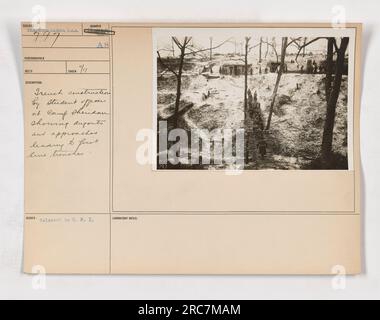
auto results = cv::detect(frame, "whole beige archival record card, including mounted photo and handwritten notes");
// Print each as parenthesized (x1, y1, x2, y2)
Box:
(22, 23, 361, 274)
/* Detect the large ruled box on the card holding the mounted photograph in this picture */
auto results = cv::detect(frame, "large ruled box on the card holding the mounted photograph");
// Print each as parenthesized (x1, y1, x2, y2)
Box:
(113, 25, 356, 213)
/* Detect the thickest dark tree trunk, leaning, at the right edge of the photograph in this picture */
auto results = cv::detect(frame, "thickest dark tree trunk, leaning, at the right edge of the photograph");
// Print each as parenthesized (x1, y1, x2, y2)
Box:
(321, 38, 349, 167)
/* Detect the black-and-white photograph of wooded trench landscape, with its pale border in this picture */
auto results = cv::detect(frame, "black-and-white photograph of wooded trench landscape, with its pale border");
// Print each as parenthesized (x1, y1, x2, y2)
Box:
(154, 30, 351, 170)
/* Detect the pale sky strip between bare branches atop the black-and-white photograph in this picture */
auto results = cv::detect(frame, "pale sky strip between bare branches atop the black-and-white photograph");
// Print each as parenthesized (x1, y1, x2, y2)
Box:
(157, 35, 332, 56)
